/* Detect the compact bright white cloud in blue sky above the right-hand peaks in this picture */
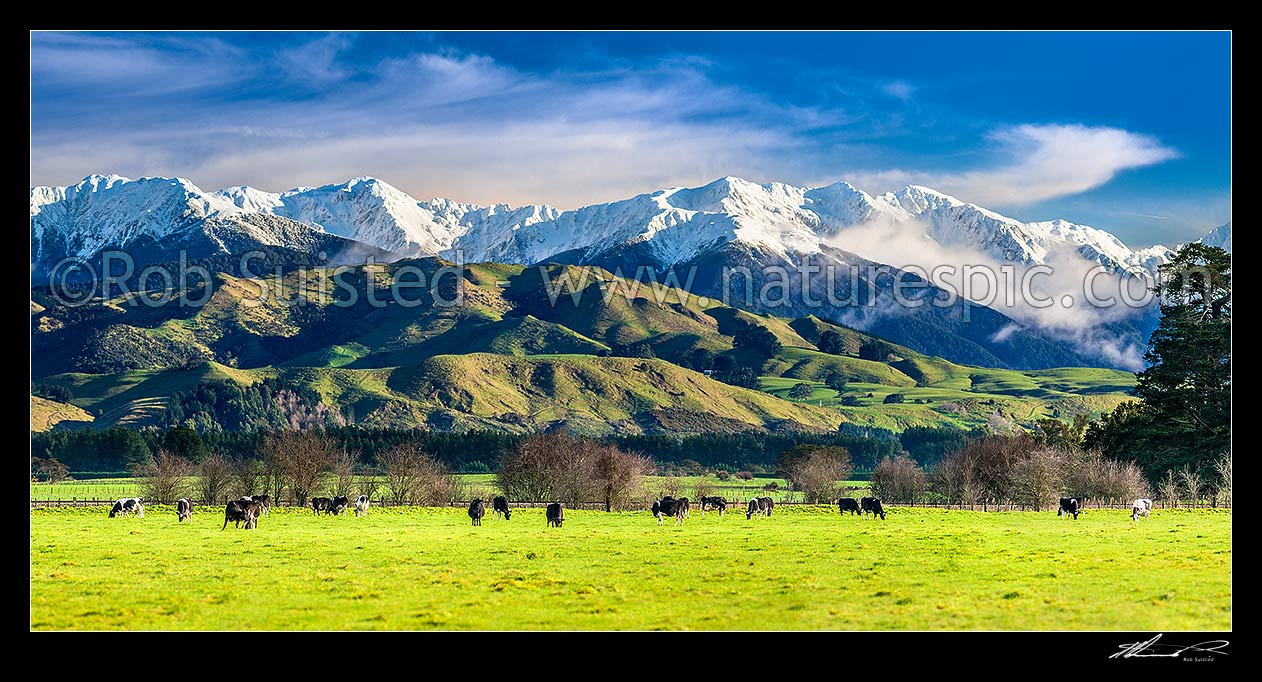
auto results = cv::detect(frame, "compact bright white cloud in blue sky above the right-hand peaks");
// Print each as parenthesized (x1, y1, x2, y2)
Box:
(852, 124, 1177, 206)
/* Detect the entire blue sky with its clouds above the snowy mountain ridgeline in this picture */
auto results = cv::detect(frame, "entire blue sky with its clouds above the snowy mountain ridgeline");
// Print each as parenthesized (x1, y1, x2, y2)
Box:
(30, 33, 1230, 246)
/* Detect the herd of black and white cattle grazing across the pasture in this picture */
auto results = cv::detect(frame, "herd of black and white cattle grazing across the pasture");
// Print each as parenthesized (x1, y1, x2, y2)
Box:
(110, 495, 1152, 530)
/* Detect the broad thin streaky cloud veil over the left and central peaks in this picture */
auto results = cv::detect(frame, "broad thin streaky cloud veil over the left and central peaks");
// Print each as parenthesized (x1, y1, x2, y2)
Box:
(32, 35, 854, 207)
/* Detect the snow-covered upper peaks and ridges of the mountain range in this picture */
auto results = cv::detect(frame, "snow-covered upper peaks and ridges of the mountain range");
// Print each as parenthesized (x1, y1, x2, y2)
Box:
(30, 176, 1230, 282)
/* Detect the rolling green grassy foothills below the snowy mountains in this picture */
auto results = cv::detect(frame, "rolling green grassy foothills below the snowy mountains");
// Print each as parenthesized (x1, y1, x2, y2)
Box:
(32, 259, 1133, 433)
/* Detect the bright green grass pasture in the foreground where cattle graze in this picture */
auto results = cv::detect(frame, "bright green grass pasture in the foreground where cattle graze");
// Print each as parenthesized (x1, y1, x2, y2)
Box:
(30, 506, 1232, 630)
